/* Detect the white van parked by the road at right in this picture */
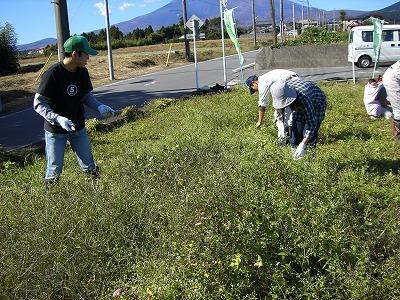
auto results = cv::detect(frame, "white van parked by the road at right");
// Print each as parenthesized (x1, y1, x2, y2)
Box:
(348, 25, 400, 68)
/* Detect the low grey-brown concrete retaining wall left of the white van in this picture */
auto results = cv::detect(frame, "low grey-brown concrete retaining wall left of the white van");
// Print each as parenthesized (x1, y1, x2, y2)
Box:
(254, 45, 349, 71)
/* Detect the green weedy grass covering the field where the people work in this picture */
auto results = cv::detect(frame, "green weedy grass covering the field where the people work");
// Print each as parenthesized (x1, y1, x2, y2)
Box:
(0, 84, 400, 299)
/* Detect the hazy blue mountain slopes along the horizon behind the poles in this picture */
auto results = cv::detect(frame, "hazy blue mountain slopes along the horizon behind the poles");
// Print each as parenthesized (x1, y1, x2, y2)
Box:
(17, 0, 400, 51)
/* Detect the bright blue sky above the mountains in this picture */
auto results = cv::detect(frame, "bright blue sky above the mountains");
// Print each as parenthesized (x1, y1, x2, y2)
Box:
(0, 0, 398, 44)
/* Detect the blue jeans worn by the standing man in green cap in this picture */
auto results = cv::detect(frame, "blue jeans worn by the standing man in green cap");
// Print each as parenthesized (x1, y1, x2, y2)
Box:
(45, 129, 96, 181)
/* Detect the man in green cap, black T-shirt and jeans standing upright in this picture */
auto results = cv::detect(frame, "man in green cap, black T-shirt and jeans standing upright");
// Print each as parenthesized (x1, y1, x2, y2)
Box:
(33, 35, 114, 183)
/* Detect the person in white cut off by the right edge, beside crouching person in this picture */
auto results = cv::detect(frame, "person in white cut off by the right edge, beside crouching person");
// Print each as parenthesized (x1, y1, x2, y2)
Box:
(382, 60, 400, 141)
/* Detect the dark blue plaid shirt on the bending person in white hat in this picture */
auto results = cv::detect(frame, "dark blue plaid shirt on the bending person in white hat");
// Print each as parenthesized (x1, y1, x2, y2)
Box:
(287, 78, 326, 138)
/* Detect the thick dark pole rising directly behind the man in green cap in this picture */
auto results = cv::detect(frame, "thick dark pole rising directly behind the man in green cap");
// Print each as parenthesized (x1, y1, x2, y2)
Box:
(52, 0, 69, 62)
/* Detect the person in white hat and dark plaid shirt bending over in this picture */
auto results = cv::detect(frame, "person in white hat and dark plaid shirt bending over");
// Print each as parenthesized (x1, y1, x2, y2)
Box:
(271, 79, 326, 160)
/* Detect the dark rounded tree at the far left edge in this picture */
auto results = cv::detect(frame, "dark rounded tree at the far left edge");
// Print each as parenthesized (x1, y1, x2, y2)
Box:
(0, 22, 19, 75)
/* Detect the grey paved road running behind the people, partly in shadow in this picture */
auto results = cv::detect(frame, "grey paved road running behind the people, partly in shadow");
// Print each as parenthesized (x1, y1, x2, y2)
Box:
(0, 51, 383, 149)
